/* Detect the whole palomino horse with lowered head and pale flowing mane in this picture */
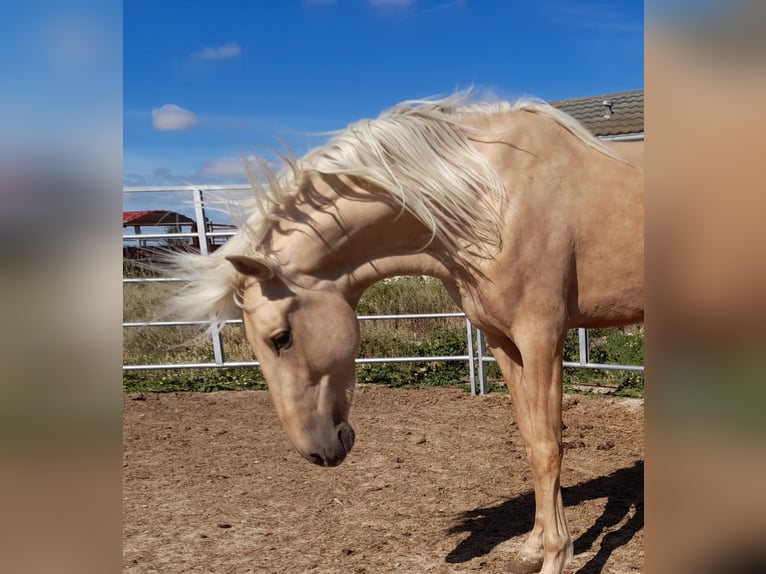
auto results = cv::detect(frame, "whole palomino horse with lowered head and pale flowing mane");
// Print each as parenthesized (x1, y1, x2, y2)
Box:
(173, 95, 644, 574)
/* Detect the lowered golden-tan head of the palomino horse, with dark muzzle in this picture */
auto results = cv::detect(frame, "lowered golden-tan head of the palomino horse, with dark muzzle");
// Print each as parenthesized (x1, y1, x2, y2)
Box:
(227, 256, 359, 466)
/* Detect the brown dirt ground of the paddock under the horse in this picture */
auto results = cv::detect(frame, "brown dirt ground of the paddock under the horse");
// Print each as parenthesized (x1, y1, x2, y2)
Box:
(123, 386, 644, 574)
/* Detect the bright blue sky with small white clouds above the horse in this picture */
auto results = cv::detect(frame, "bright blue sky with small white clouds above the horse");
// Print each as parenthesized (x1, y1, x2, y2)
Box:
(123, 0, 644, 202)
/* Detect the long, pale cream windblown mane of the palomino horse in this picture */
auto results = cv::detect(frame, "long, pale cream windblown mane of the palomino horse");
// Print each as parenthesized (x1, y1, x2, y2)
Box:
(169, 92, 619, 329)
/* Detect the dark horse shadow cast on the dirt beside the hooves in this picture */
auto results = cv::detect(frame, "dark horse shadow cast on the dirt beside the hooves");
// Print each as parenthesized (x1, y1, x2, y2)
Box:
(446, 460, 644, 574)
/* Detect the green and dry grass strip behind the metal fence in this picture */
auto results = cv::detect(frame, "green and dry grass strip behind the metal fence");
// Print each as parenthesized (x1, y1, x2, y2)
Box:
(123, 270, 643, 396)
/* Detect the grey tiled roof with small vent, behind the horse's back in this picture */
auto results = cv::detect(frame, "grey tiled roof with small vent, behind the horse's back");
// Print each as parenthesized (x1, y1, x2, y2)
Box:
(550, 90, 644, 140)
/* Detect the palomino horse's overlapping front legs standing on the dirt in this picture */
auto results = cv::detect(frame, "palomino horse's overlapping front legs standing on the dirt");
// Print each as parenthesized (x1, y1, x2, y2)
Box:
(492, 331, 572, 574)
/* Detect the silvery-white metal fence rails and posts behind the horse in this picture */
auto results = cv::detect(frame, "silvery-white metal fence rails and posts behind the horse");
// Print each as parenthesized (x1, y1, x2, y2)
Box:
(122, 185, 644, 394)
